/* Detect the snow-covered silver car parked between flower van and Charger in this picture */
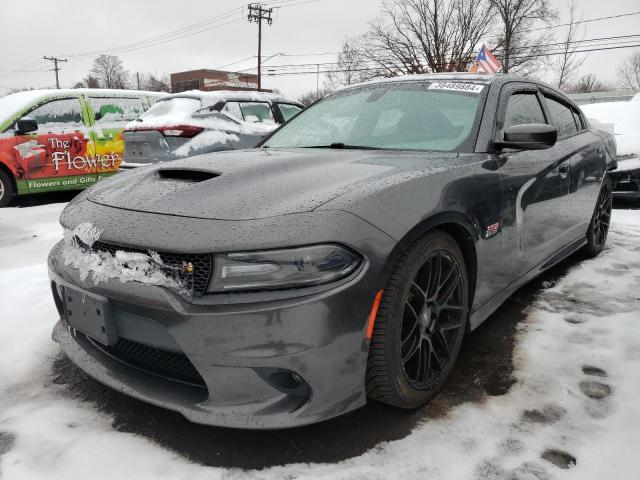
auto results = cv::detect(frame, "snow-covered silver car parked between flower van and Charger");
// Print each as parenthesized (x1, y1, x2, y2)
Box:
(121, 90, 304, 168)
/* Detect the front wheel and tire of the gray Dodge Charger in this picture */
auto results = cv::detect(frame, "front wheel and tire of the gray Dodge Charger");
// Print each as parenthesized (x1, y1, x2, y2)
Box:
(366, 230, 469, 409)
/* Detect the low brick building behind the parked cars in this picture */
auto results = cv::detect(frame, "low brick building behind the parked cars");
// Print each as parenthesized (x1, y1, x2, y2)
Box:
(171, 69, 258, 93)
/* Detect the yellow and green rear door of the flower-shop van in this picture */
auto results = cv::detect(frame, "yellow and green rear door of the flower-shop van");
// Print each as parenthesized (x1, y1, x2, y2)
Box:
(88, 95, 145, 180)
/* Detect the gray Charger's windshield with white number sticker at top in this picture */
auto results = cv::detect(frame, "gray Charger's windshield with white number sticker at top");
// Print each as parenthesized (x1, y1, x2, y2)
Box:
(263, 82, 484, 151)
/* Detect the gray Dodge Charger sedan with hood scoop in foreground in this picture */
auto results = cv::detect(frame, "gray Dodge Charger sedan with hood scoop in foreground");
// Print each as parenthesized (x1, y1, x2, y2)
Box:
(49, 74, 615, 428)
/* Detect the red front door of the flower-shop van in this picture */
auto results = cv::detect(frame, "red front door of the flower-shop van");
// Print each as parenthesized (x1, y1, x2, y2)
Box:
(15, 97, 96, 193)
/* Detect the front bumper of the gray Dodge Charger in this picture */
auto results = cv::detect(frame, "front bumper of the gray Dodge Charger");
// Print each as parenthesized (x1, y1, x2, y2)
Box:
(49, 208, 393, 428)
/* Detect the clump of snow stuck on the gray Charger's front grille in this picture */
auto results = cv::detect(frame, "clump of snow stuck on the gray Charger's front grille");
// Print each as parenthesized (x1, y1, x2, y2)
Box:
(62, 223, 184, 291)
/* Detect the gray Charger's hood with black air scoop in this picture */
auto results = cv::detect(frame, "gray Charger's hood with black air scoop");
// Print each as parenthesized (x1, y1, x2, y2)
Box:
(88, 149, 458, 220)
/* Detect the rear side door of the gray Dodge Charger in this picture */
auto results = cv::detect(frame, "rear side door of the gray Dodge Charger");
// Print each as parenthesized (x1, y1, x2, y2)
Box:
(543, 90, 606, 242)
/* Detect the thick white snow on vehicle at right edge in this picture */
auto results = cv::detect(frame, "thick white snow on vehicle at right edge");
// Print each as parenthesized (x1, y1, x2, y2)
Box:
(580, 101, 640, 155)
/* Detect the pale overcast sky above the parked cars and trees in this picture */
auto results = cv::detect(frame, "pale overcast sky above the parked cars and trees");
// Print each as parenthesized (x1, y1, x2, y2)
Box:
(0, 0, 640, 98)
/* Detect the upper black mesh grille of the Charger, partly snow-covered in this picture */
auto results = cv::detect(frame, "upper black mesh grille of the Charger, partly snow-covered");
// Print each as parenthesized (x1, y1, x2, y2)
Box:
(76, 238, 213, 295)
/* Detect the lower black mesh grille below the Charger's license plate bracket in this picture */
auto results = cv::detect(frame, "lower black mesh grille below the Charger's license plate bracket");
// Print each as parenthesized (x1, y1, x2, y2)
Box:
(87, 337, 207, 387)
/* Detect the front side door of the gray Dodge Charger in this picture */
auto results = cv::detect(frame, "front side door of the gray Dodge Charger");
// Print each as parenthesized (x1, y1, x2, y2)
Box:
(496, 83, 570, 279)
